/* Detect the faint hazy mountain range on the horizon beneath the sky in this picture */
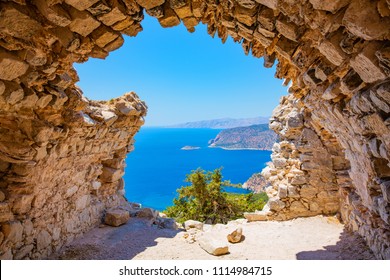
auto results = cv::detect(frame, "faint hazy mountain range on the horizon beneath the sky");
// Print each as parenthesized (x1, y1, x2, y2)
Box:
(167, 117, 269, 129)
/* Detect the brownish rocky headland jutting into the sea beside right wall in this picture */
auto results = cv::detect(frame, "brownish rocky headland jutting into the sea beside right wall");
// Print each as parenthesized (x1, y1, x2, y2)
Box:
(209, 124, 277, 150)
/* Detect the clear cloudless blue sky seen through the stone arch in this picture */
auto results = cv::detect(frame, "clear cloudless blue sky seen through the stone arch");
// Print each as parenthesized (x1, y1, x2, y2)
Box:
(75, 14, 287, 126)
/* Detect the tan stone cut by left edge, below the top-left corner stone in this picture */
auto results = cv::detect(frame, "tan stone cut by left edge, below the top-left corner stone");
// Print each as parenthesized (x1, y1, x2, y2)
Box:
(0, 49, 29, 80)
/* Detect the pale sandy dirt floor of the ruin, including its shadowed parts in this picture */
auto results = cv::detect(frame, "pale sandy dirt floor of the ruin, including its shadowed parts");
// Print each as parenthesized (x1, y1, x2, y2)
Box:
(50, 216, 374, 260)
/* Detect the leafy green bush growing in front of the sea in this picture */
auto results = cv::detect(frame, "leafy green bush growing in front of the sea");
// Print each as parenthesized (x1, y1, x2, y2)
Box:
(165, 169, 268, 224)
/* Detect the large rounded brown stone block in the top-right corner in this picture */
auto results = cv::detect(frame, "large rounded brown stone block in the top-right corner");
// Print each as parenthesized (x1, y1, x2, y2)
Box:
(342, 0, 390, 40)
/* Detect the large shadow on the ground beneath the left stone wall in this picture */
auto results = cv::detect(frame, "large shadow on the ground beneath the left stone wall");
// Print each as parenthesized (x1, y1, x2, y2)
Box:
(50, 218, 180, 260)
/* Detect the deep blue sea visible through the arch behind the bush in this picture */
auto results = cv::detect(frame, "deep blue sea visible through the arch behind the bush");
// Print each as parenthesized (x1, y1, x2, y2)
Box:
(124, 127, 271, 210)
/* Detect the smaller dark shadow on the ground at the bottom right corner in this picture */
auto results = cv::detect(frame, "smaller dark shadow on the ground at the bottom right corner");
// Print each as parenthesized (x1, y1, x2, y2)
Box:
(296, 229, 375, 260)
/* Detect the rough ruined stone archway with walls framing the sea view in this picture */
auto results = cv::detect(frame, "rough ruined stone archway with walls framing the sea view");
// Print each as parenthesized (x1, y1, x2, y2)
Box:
(0, 0, 390, 259)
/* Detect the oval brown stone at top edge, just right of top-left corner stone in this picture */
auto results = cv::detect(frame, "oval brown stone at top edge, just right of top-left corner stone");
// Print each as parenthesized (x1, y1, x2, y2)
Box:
(34, 0, 71, 27)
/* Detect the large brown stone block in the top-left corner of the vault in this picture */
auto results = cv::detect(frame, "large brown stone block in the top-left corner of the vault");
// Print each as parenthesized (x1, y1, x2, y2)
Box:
(0, 3, 42, 40)
